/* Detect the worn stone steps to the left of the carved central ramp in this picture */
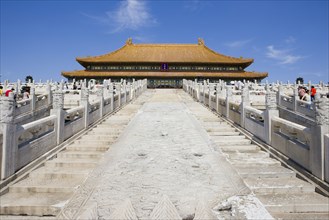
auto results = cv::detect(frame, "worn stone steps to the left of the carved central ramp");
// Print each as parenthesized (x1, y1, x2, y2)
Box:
(0, 99, 145, 219)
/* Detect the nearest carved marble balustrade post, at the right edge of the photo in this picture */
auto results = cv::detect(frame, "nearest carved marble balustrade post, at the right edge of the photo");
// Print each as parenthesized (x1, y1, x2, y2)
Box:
(310, 93, 329, 180)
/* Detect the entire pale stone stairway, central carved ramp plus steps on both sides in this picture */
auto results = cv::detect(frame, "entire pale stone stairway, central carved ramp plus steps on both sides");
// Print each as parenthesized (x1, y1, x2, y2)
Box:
(0, 90, 329, 220)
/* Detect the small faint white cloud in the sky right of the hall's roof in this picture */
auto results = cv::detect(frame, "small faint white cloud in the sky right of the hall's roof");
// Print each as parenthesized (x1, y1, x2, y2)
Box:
(266, 45, 304, 64)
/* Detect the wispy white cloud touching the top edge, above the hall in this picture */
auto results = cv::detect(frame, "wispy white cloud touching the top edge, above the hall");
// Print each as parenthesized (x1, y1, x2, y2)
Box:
(84, 0, 156, 33)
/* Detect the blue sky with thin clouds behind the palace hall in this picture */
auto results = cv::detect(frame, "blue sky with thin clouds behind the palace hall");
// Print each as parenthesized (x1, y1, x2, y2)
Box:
(0, 0, 329, 82)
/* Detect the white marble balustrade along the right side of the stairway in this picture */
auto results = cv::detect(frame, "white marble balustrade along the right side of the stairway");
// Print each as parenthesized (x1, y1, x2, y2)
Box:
(183, 80, 329, 182)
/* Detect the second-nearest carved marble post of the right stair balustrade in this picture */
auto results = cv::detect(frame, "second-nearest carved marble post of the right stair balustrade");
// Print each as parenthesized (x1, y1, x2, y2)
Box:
(264, 84, 279, 144)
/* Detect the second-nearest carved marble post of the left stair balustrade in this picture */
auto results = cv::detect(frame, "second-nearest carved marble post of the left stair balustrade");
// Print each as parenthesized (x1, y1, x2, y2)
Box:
(50, 89, 65, 145)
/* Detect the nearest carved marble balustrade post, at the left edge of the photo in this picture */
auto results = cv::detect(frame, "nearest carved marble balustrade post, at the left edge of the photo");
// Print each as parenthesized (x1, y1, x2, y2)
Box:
(0, 92, 18, 180)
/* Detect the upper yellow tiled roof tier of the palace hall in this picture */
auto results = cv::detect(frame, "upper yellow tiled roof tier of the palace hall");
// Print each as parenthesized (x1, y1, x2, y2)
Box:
(76, 39, 253, 67)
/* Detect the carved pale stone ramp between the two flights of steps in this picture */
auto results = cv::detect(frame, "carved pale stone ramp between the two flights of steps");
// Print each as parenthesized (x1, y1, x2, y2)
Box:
(74, 90, 249, 219)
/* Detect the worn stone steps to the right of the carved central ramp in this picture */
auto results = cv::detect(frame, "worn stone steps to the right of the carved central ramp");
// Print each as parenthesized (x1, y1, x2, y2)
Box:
(182, 92, 329, 219)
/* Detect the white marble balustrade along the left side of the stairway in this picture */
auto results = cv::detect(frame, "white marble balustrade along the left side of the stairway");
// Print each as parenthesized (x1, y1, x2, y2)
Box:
(0, 80, 147, 180)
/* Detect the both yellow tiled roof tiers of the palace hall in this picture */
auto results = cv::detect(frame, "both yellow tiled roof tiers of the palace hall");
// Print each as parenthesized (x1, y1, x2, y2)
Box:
(62, 38, 268, 79)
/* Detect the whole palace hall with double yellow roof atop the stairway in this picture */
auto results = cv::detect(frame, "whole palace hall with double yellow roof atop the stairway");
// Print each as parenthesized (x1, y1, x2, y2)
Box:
(62, 38, 268, 88)
